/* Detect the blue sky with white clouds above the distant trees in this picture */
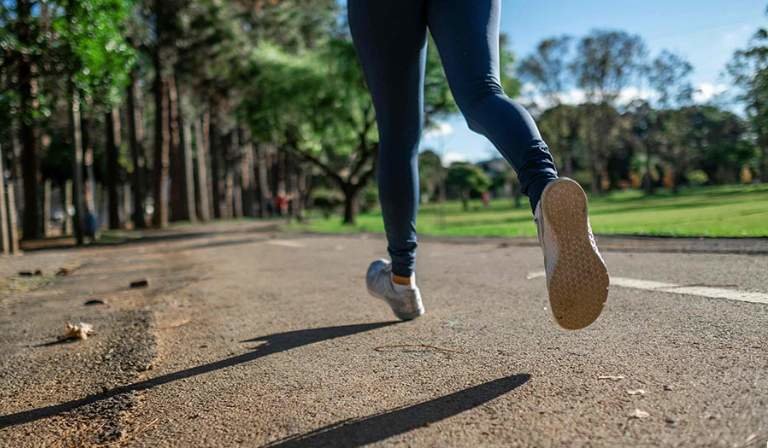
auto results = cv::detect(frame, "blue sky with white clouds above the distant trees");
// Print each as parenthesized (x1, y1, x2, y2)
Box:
(414, 0, 768, 162)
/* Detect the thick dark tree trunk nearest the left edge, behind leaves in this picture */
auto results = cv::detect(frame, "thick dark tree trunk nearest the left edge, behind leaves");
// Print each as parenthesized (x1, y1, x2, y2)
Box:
(16, 0, 42, 239)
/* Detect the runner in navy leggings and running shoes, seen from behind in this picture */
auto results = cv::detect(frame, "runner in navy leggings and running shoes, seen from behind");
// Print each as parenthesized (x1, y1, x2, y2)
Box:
(348, 0, 608, 329)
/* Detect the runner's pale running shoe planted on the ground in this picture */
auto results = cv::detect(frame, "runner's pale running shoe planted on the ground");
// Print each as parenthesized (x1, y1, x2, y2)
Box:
(365, 260, 424, 320)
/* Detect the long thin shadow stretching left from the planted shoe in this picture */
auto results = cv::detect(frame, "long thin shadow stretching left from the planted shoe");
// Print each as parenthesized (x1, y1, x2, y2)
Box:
(0, 322, 398, 429)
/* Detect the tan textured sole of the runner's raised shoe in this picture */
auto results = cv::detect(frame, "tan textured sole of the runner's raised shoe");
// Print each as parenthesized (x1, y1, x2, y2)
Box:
(541, 178, 610, 330)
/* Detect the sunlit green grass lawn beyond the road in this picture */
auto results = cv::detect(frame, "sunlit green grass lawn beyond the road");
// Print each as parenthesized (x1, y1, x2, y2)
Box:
(289, 185, 768, 237)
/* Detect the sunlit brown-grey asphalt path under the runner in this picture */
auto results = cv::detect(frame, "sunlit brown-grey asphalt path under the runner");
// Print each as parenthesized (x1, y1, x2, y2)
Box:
(0, 223, 768, 448)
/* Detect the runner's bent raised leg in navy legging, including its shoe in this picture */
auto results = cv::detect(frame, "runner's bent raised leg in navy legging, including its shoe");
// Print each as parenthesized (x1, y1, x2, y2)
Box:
(427, 0, 609, 329)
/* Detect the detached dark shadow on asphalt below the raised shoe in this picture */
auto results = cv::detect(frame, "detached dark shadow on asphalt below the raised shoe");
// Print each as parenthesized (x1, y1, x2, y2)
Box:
(264, 374, 531, 448)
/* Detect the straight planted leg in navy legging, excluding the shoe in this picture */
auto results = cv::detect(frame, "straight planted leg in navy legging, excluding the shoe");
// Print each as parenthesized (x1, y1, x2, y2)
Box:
(348, 0, 427, 277)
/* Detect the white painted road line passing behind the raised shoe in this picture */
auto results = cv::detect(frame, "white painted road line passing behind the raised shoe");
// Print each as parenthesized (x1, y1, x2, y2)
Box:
(525, 271, 768, 305)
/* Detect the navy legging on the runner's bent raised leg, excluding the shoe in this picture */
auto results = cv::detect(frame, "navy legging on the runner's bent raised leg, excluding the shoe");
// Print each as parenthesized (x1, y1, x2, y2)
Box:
(427, 0, 557, 209)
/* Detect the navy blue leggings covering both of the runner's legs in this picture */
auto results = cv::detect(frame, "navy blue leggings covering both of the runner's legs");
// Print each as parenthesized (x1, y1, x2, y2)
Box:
(348, 0, 557, 277)
